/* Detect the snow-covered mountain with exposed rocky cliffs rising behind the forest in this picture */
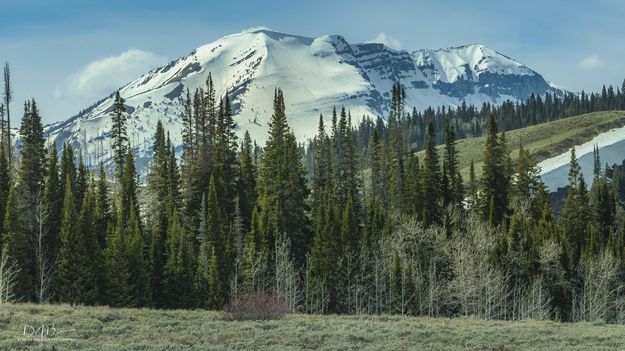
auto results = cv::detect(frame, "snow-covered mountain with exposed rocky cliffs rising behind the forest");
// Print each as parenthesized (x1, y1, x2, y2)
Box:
(46, 29, 564, 172)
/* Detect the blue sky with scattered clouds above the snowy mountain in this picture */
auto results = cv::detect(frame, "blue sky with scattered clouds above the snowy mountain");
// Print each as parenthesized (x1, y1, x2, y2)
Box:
(0, 0, 625, 123)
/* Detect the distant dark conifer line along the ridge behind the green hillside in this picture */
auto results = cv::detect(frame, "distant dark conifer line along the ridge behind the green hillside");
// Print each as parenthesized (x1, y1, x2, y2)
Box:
(312, 80, 625, 175)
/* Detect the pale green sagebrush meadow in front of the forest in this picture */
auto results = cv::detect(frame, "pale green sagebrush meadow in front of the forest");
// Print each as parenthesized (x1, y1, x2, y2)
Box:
(0, 304, 625, 350)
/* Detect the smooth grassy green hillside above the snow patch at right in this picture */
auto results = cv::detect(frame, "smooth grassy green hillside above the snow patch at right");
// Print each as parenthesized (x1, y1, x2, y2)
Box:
(418, 111, 625, 181)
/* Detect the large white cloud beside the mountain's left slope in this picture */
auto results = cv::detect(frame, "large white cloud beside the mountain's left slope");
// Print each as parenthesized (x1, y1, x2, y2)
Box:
(55, 49, 167, 97)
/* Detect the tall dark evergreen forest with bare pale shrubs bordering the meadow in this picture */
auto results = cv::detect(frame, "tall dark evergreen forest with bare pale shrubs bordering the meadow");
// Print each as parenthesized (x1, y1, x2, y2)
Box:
(0, 64, 625, 322)
